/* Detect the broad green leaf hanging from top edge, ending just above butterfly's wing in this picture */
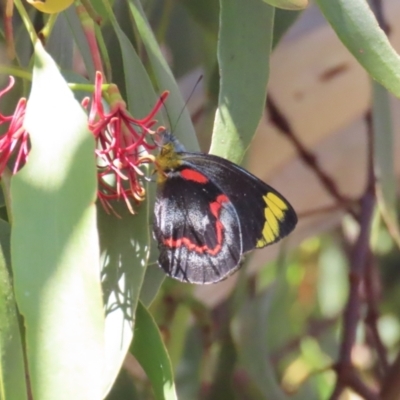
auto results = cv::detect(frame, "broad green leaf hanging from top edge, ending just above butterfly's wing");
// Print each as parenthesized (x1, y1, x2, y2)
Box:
(210, 0, 274, 162)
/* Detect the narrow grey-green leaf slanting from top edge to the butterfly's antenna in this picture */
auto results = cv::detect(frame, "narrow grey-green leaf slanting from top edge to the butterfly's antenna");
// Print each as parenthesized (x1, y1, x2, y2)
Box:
(129, 0, 199, 151)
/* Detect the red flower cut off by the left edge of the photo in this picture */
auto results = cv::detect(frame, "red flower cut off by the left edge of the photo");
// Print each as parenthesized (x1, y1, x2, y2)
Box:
(0, 76, 29, 175)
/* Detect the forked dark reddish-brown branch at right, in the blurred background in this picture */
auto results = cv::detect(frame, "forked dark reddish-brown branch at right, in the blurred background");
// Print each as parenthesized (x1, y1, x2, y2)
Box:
(267, 97, 387, 400)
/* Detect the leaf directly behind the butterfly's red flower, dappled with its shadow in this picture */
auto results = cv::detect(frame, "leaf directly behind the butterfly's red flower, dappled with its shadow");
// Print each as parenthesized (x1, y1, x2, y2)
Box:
(85, 1, 168, 395)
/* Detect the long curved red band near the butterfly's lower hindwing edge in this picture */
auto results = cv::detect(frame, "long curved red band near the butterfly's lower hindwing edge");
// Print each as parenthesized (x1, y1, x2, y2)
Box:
(164, 194, 229, 256)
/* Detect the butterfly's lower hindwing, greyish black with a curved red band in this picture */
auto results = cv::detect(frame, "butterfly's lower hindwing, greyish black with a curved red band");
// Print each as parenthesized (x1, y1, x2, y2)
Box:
(153, 173, 242, 284)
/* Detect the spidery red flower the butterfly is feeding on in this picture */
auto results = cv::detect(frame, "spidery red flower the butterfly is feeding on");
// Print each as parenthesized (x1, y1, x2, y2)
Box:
(84, 72, 168, 213)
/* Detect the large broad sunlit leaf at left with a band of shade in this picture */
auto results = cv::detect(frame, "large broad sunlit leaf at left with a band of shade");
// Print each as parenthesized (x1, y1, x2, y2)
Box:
(11, 42, 104, 400)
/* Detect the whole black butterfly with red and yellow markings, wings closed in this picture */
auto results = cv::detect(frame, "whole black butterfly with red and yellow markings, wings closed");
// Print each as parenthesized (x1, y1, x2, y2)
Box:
(153, 133, 297, 284)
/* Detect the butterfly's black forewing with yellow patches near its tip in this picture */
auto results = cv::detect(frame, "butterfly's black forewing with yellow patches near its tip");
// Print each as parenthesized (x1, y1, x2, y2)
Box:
(180, 153, 297, 253)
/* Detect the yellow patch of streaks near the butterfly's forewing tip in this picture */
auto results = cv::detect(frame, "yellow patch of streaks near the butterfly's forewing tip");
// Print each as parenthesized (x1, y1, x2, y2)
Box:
(256, 192, 288, 247)
